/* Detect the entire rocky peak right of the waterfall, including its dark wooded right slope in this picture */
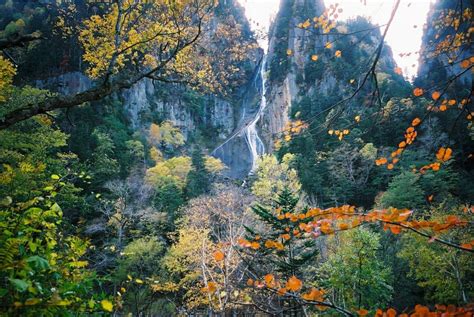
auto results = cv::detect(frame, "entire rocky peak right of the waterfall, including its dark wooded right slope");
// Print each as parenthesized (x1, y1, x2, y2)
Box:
(259, 0, 406, 152)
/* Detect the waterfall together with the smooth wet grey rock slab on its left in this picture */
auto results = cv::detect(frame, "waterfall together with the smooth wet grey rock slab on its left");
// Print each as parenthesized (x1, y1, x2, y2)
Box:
(211, 55, 267, 178)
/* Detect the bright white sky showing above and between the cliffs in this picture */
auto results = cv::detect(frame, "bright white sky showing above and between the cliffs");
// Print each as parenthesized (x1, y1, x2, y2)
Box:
(239, 0, 433, 78)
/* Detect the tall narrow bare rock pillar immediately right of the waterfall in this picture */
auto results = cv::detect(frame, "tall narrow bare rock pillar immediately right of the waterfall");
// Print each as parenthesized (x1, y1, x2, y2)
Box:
(260, 0, 324, 152)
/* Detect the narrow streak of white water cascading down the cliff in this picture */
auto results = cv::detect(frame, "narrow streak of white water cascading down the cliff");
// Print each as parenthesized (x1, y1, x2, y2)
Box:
(244, 55, 267, 173)
